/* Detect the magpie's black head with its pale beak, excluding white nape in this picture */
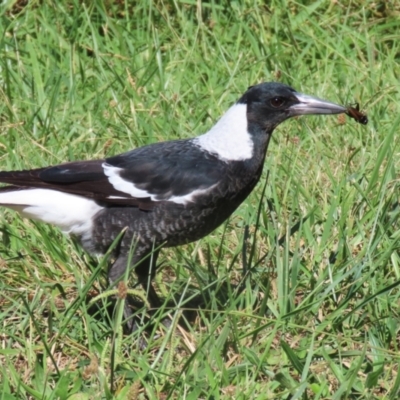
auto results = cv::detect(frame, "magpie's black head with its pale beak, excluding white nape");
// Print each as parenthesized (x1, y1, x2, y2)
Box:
(238, 82, 347, 131)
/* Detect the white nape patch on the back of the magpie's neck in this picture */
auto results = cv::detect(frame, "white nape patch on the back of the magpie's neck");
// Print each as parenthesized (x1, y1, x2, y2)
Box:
(193, 104, 254, 161)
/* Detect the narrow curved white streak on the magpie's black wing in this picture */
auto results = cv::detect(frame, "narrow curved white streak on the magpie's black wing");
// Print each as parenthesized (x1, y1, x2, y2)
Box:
(102, 163, 217, 204)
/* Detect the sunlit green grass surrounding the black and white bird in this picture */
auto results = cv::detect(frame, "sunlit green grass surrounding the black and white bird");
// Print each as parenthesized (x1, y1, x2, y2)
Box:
(0, 0, 400, 400)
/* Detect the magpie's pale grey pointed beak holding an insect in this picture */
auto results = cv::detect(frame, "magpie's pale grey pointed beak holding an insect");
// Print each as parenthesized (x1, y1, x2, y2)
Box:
(289, 92, 347, 116)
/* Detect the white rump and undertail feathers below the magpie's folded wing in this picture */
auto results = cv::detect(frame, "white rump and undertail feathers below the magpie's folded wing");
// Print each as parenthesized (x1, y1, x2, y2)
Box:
(0, 189, 103, 236)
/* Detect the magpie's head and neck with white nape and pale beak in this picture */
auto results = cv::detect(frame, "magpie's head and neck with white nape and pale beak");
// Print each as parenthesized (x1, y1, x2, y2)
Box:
(195, 82, 347, 161)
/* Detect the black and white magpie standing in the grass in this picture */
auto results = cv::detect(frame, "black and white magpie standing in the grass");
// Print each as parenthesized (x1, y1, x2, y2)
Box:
(0, 82, 346, 328)
